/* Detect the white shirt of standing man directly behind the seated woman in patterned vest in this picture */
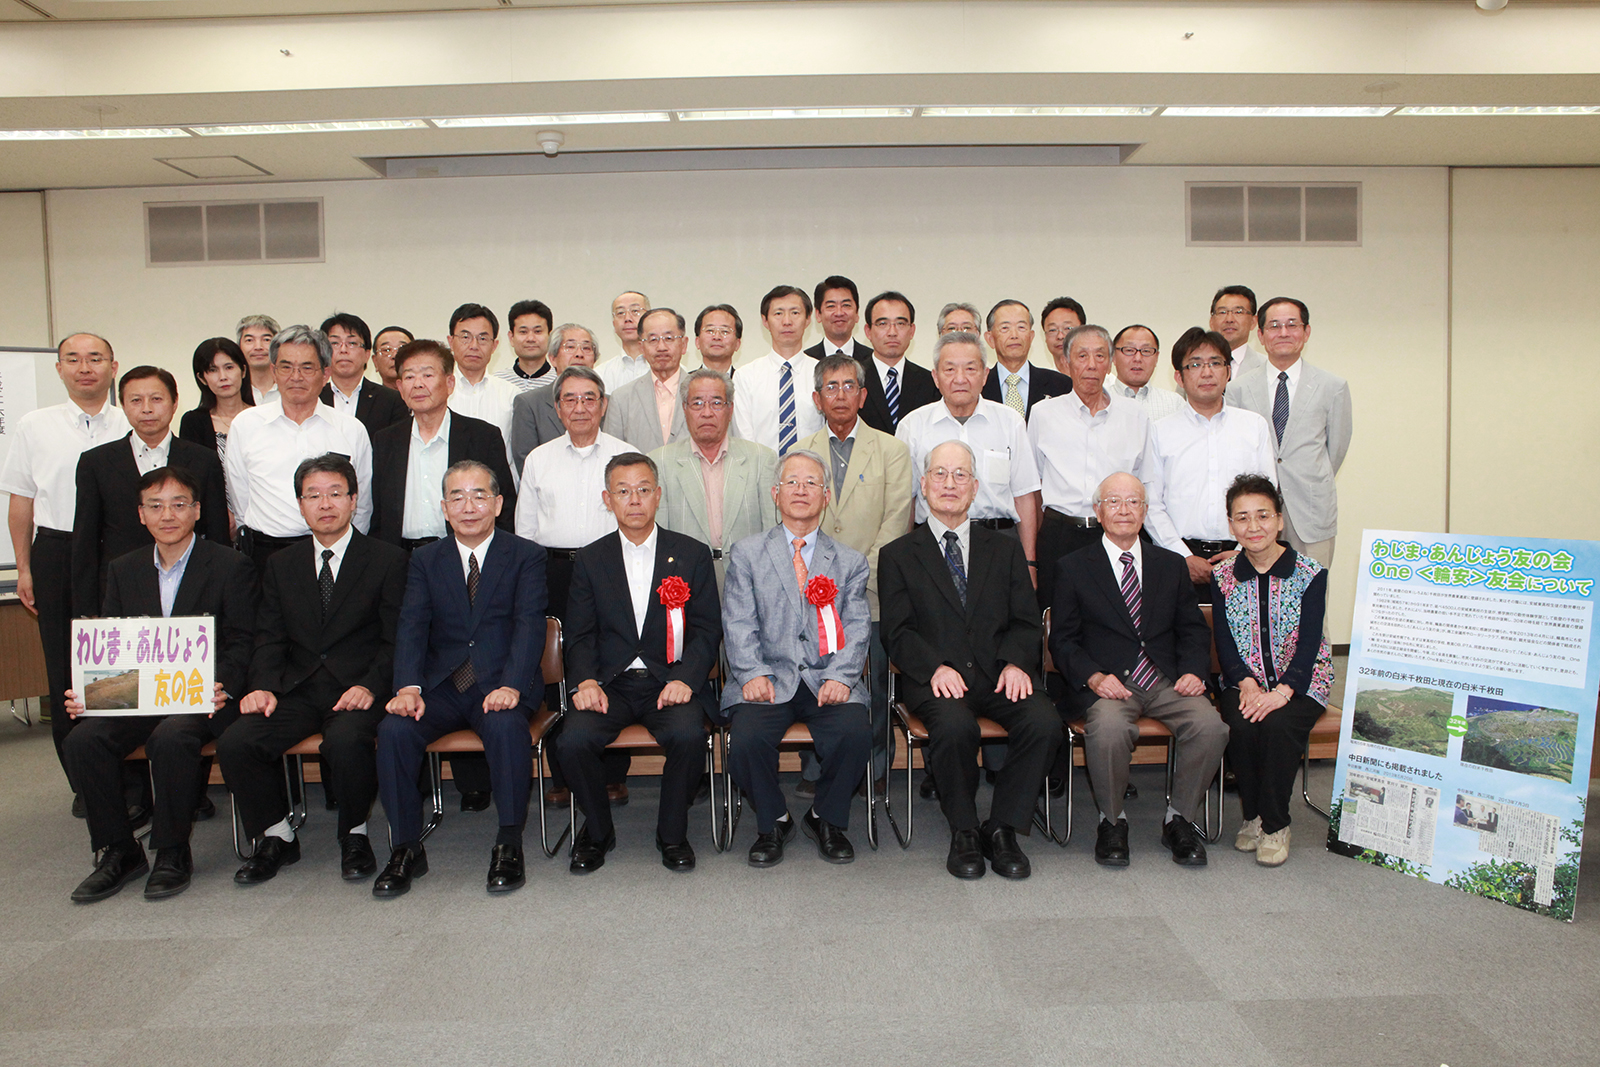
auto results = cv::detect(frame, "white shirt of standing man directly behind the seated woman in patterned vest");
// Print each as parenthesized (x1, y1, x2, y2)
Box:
(1141, 405, 1278, 555)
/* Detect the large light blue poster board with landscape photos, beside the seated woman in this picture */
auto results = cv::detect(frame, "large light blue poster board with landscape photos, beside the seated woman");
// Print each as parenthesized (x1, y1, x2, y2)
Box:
(1328, 530, 1600, 920)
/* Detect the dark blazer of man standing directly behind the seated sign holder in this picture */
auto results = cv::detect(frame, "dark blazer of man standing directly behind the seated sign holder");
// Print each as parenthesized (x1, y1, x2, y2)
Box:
(72, 431, 230, 617)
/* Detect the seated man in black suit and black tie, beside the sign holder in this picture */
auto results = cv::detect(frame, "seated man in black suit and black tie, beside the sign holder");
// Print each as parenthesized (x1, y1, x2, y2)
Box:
(216, 454, 406, 885)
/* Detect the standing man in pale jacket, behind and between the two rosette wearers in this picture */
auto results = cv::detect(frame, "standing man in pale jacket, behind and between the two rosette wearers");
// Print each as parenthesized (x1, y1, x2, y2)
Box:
(650, 366, 778, 589)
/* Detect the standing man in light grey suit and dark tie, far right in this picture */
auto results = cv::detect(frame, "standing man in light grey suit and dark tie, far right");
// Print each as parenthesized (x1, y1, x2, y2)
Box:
(1227, 296, 1350, 568)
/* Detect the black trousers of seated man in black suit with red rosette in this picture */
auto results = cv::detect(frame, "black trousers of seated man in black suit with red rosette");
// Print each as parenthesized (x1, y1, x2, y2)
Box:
(555, 675, 706, 845)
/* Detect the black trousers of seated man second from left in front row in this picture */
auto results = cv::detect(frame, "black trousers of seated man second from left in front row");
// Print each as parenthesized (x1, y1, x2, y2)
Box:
(216, 670, 384, 838)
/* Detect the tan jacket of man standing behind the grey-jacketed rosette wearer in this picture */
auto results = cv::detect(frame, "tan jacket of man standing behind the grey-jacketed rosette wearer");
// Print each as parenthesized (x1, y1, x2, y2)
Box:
(800, 421, 915, 619)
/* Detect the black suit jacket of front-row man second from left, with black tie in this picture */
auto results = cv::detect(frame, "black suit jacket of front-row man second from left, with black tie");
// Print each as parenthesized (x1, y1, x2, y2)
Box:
(250, 530, 408, 704)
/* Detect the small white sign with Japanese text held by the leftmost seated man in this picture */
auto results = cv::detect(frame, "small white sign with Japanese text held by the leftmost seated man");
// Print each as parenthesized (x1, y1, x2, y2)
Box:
(72, 616, 216, 715)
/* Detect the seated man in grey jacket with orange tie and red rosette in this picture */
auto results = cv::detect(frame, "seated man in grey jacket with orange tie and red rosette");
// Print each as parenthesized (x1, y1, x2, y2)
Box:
(722, 448, 872, 867)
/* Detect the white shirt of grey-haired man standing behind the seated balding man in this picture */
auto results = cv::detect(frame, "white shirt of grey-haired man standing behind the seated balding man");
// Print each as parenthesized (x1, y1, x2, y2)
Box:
(1027, 392, 1150, 518)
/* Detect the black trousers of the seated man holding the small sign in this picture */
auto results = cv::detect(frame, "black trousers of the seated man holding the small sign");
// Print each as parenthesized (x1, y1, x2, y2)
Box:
(62, 704, 238, 851)
